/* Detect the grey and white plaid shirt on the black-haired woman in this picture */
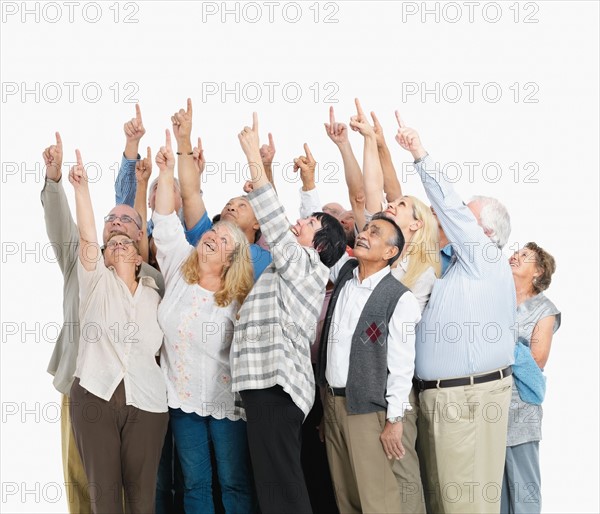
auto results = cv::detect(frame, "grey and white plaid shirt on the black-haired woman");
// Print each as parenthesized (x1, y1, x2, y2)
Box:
(231, 184, 329, 416)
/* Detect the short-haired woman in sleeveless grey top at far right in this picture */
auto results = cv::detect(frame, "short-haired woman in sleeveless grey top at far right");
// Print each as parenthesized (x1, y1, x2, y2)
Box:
(500, 243, 560, 513)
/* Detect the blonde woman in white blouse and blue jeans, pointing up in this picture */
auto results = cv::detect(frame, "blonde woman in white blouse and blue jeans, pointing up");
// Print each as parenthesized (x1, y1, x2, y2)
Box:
(153, 131, 256, 514)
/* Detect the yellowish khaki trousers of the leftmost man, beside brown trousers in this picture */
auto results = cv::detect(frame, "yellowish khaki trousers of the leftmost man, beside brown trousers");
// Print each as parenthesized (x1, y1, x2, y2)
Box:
(60, 394, 92, 514)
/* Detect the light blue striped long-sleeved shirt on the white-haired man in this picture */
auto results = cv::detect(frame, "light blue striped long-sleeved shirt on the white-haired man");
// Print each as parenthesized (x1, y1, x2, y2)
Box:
(415, 157, 517, 380)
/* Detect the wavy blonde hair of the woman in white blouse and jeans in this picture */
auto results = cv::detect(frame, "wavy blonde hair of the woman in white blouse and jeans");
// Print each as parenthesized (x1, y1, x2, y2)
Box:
(181, 221, 254, 307)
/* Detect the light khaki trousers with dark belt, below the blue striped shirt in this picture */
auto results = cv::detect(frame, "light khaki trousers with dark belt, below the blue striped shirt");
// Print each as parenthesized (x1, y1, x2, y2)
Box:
(418, 376, 513, 514)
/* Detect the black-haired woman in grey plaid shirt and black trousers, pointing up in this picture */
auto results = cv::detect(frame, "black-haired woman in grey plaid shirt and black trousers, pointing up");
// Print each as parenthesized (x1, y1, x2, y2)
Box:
(231, 113, 346, 514)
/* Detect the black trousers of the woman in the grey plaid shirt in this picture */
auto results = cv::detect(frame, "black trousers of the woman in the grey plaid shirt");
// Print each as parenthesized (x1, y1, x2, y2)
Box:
(241, 386, 312, 514)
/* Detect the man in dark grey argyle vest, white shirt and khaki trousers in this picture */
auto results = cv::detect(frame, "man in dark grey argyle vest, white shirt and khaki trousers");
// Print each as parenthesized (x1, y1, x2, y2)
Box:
(317, 214, 421, 513)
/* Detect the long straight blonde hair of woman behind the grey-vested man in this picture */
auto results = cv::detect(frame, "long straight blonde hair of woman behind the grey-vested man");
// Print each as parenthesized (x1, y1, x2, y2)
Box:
(401, 196, 442, 289)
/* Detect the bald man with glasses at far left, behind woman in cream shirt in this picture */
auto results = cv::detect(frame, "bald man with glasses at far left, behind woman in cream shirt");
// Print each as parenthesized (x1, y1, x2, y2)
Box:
(41, 132, 164, 514)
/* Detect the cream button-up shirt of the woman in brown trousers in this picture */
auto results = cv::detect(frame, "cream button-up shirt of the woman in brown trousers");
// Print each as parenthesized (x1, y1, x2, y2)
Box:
(75, 260, 168, 412)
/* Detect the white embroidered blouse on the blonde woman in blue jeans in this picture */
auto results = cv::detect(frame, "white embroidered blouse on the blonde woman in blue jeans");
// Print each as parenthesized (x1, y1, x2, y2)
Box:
(152, 212, 243, 421)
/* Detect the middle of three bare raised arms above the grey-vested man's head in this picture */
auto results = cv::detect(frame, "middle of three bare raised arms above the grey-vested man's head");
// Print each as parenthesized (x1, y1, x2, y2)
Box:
(350, 98, 383, 213)
